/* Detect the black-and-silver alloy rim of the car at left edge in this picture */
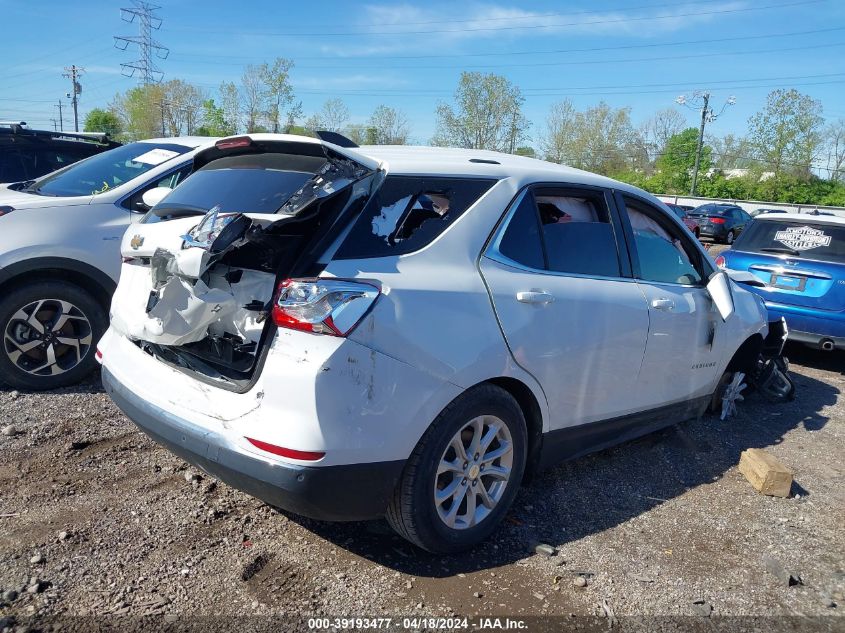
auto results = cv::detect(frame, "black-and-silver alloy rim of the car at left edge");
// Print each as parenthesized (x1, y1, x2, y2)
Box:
(3, 299, 94, 376)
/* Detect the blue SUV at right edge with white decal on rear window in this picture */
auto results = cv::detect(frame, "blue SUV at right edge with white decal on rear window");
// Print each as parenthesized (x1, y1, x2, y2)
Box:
(716, 213, 845, 350)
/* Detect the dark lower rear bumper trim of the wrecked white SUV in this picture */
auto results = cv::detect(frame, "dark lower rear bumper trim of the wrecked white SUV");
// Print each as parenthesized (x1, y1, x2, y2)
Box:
(102, 367, 405, 521)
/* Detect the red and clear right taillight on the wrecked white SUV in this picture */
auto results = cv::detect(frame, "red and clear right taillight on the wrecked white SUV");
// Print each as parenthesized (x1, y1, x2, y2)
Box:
(273, 278, 381, 336)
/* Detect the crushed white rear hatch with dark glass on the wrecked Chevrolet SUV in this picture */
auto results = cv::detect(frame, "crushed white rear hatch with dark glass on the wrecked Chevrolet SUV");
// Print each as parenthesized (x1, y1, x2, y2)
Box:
(112, 135, 381, 390)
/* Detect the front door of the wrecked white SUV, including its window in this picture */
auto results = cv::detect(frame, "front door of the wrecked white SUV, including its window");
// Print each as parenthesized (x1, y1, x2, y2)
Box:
(619, 195, 727, 408)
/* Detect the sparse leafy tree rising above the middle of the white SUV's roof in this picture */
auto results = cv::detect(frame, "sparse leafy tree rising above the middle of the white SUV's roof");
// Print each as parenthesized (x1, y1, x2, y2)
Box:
(432, 72, 530, 153)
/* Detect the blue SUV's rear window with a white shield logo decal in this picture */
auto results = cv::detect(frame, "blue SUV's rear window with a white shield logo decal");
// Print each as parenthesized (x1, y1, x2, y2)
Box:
(734, 220, 845, 263)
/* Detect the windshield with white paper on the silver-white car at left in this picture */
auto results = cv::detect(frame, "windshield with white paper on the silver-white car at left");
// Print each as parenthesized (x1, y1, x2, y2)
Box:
(24, 143, 191, 196)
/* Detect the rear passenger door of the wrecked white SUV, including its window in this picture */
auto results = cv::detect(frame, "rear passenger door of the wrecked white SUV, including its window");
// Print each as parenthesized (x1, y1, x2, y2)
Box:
(480, 186, 648, 430)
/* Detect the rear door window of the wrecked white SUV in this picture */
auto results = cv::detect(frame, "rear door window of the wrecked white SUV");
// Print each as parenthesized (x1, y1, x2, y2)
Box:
(497, 188, 621, 277)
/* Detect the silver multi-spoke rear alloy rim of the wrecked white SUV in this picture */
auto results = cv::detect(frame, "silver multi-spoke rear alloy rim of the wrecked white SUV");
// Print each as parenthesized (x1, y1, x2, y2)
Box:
(434, 415, 513, 530)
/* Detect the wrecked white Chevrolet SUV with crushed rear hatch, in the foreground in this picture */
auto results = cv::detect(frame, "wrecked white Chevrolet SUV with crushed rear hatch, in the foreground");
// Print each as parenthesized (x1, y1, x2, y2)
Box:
(98, 134, 780, 552)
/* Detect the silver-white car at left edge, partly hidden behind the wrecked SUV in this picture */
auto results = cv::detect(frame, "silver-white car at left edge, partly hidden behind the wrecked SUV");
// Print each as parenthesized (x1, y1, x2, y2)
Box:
(0, 137, 218, 390)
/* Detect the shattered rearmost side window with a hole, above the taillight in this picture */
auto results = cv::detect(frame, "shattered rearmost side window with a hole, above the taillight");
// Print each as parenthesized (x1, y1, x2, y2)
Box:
(334, 176, 496, 259)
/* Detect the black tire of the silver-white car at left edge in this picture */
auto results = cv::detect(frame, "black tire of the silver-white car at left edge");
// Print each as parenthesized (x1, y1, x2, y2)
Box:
(0, 281, 108, 391)
